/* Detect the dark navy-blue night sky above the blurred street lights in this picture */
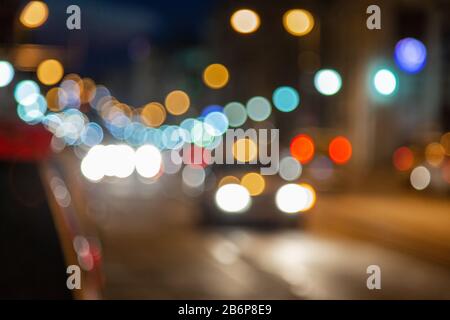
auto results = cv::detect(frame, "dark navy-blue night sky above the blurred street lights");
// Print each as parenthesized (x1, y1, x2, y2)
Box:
(18, 0, 223, 72)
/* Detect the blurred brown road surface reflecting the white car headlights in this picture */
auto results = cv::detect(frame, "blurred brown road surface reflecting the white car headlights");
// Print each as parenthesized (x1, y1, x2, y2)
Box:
(44, 151, 450, 299)
